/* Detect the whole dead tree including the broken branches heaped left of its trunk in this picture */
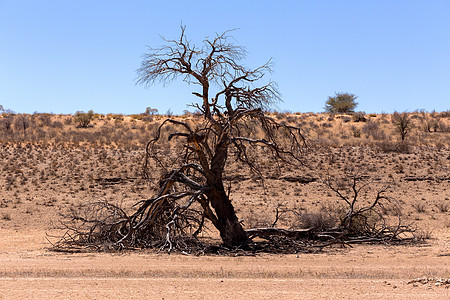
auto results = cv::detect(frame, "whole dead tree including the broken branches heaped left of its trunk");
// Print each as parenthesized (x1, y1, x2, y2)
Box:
(50, 27, 306, 251)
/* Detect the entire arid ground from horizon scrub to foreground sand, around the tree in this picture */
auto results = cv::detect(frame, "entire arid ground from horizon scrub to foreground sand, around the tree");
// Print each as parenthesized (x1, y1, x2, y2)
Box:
(0, 112, 450, 299)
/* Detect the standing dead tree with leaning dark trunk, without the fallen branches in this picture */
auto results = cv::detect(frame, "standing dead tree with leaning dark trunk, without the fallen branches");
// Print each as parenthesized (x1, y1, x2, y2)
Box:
(133, 27, 304, 247)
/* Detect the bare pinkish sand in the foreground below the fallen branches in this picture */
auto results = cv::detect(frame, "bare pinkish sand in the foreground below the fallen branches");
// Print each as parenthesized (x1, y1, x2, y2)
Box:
(0, 229, 450, 299)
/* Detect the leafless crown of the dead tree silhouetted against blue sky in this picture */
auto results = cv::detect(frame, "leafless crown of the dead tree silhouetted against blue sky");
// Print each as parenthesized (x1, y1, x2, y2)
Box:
(137, 27, 279, 120)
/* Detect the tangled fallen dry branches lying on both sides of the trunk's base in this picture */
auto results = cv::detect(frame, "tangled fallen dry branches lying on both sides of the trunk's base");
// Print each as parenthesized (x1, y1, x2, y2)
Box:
(53, 177, 420, 255)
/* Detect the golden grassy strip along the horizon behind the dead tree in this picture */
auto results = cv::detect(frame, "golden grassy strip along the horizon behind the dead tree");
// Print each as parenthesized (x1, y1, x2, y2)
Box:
(0, 111, 450, 152)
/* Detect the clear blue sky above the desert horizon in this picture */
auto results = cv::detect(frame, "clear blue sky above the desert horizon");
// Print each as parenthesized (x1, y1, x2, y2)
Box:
(0, 0, 450, 114)
